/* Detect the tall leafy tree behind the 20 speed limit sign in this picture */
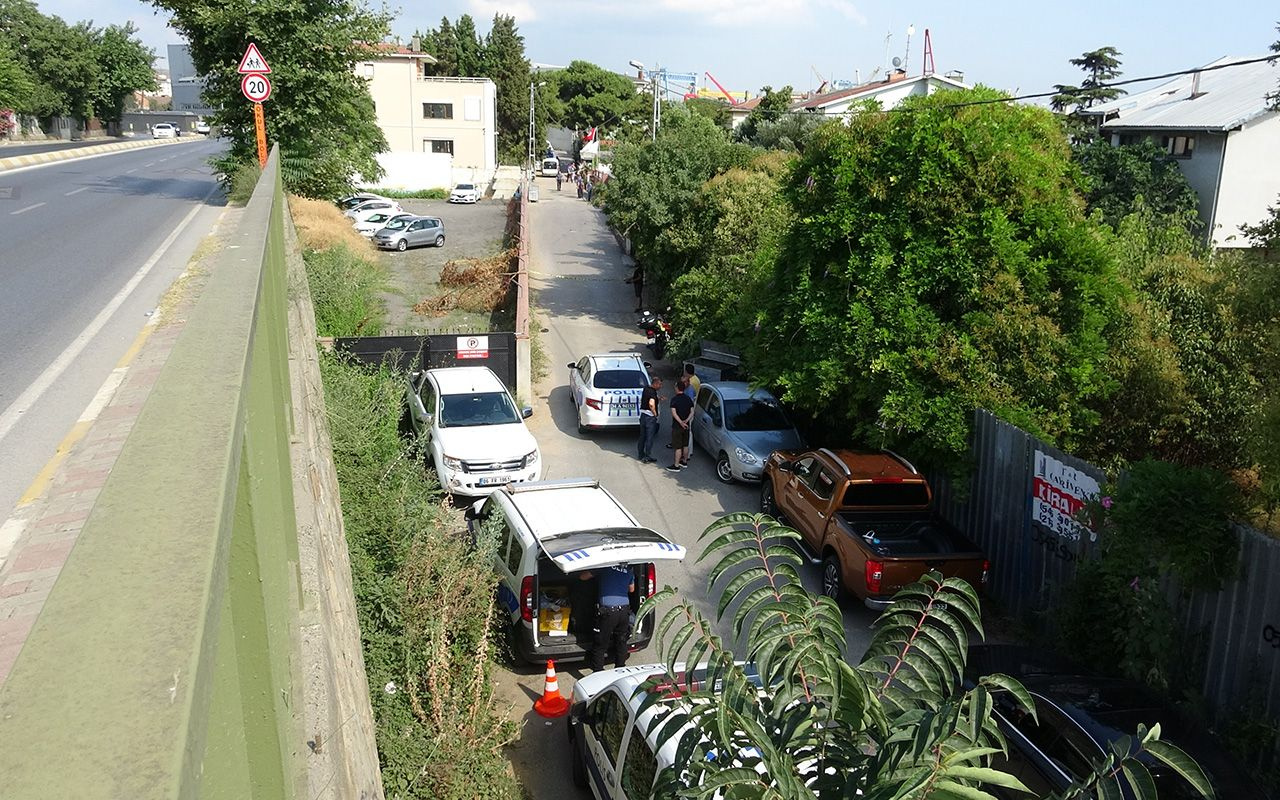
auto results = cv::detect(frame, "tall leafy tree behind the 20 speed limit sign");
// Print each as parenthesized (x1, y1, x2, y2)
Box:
(146, 0, 388, 197)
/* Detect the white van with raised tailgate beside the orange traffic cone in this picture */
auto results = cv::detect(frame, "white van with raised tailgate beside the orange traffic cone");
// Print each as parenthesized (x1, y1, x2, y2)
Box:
(467, 479, 685, 663)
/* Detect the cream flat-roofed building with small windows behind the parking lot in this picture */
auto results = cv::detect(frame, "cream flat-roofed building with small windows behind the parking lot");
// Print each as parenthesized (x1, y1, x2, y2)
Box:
(356, 45, 498, 188)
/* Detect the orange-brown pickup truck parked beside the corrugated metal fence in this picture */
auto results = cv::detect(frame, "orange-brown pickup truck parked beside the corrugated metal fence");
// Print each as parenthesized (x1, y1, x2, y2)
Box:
(760, 448, 991, 611)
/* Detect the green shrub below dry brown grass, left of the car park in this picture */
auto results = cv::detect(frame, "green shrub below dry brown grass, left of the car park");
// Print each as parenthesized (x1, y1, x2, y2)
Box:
(302, 244, 387, 337)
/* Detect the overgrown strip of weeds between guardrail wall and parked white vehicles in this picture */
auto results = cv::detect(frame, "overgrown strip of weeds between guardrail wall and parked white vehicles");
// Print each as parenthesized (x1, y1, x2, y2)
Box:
(320, 353, 521, 800)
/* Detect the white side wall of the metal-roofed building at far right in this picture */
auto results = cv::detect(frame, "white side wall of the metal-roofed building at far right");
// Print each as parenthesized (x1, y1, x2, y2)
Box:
(1197, 111, 1280, 247)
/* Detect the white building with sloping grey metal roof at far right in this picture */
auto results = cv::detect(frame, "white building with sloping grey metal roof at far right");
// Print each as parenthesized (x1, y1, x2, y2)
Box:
(1087, 56, 1280, 247)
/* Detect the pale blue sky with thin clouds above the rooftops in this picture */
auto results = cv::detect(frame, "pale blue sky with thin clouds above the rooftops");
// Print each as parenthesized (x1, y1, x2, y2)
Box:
(36, 0, 1280, 101)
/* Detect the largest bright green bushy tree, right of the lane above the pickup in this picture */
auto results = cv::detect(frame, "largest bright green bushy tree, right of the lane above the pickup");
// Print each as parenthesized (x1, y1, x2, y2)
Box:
(749, 90, 1125, 463)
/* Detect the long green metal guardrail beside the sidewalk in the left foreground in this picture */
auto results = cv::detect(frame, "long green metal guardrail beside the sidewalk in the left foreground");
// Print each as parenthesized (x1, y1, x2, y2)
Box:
(0, 148, 306, 800)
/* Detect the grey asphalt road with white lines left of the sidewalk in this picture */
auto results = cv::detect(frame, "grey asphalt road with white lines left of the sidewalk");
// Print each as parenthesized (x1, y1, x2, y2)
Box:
(0, 138, 224, 522)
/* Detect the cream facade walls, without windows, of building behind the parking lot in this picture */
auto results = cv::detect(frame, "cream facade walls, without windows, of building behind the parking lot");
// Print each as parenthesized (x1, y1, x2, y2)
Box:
(366, 55, 498, 170)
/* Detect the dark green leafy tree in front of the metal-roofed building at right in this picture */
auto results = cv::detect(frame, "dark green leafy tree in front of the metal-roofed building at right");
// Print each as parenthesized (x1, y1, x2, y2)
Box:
(1073, 138, 1202, 233)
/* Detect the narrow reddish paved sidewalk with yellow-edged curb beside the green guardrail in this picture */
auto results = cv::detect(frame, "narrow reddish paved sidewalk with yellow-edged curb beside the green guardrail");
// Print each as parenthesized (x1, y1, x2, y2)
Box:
(0, 207, 242, 685)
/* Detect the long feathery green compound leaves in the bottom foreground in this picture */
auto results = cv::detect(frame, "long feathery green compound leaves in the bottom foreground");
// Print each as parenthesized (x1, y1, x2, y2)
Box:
(640, 513, 1213, 800)
